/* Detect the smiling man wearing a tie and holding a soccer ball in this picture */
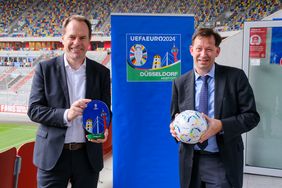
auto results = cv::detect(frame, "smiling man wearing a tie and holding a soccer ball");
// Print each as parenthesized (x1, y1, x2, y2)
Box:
(170, 28, 260, 188)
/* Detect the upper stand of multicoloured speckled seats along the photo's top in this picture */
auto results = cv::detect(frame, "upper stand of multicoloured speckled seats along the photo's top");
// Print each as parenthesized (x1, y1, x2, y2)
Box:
(0, 0, 281, 37)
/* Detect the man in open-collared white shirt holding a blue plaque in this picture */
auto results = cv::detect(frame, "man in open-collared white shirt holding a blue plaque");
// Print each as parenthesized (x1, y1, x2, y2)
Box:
(28, 15, 111, 188)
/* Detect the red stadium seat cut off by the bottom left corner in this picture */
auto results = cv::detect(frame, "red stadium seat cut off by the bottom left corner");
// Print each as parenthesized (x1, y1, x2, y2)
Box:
(0, 147, 17, 188)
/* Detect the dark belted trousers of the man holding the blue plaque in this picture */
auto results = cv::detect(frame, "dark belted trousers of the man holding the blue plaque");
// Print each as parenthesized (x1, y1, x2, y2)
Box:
(37, 148, 99, 188)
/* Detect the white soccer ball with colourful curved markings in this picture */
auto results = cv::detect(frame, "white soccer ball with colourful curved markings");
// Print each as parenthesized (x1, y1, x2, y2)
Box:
(173, 110, 208, 144)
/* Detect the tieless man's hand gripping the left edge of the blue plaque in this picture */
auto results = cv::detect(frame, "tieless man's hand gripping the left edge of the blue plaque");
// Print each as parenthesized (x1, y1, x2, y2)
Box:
(67, 99, 91, 121)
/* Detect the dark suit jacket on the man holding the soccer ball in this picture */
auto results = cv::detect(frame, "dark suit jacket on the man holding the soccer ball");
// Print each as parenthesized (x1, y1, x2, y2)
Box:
(171, 64, 260, 188)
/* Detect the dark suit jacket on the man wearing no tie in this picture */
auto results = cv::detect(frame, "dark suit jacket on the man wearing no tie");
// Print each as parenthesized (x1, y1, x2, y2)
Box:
(28, 56, 111, 172)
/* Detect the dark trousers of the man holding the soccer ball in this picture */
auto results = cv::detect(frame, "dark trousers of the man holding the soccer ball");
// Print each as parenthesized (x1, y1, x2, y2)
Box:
(190, 153, 232, 188)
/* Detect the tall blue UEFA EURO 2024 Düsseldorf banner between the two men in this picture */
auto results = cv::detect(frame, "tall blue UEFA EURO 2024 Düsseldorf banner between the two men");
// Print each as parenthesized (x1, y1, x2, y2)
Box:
(111, 14, 194, 188)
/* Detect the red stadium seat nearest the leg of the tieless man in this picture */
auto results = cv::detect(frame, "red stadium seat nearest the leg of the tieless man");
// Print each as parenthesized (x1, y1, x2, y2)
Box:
(18, 142, 37, 188)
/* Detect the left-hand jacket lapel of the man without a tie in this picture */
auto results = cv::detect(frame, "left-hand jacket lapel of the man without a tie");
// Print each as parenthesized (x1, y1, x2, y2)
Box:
(56, 55, 70, 107)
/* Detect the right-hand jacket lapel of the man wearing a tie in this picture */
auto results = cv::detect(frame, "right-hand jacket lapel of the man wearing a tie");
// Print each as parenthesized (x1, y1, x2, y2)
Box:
(214, 64, 226, 119)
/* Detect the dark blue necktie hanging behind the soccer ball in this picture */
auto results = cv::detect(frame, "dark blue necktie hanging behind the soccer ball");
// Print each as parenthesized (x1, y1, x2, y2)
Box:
(197, 75, 209, 150)
